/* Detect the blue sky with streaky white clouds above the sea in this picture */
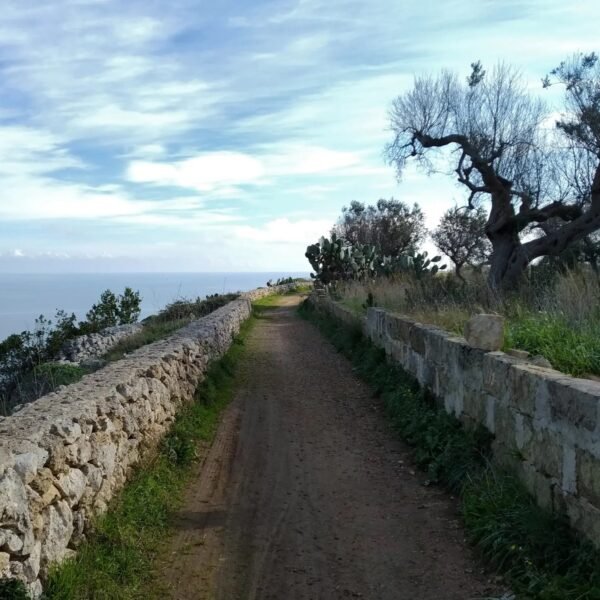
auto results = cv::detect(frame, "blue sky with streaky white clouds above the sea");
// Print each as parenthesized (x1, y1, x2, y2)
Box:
(0, 0, 600, 272)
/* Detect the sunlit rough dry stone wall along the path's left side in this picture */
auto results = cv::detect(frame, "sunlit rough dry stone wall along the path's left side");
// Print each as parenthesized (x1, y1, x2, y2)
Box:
(0, 286, 302, 597)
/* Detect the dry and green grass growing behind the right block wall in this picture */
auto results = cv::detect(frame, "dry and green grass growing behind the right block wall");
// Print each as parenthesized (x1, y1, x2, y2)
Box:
(336, 271, 600, 377)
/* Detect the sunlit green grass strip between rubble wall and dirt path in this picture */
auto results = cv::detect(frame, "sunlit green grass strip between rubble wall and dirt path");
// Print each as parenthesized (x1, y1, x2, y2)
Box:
(45, 318, 254, 600)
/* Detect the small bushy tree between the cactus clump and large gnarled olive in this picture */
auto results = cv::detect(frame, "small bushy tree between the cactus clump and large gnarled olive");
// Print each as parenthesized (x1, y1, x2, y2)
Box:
(431, 207, 491, 279)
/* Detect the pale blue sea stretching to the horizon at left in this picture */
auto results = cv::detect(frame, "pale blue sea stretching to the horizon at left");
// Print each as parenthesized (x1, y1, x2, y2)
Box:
(0, 272, 308, 341)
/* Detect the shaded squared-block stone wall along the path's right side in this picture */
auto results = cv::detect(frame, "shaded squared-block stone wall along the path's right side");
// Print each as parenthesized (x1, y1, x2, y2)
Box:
(311, 296, 600, 545)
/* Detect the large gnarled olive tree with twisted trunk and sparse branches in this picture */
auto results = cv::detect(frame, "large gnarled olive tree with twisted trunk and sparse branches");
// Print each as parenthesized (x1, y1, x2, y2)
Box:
(386, 55, 600, 288)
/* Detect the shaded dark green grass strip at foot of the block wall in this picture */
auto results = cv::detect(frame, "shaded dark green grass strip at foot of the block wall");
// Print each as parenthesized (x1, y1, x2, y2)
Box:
(300, 303, 600, 600)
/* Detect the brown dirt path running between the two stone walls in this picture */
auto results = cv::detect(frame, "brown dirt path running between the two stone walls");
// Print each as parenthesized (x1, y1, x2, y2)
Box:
(165, 298, 500, 600)
